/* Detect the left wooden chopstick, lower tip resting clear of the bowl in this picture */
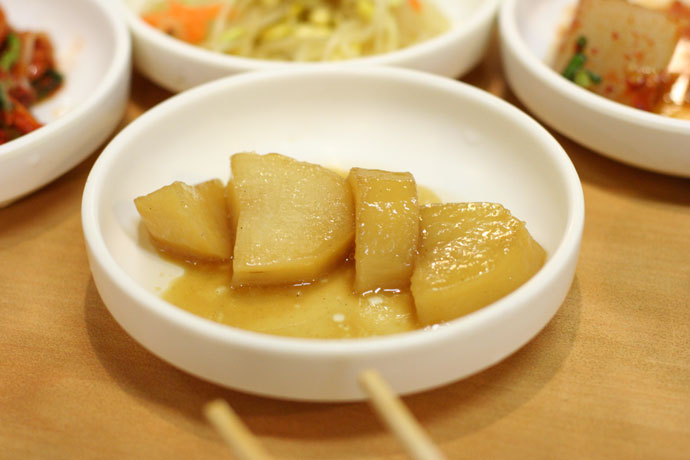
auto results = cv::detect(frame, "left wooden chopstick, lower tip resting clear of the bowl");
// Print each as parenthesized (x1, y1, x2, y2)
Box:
(204, 399, 271, 460)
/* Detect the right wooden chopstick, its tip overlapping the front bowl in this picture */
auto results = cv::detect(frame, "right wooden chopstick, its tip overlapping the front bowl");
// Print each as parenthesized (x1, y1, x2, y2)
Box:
(359, 370, 445, 460)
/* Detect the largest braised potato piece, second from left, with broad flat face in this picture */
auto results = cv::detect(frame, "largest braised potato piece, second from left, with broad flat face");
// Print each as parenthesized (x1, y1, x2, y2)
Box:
(227, 153, 355, 286)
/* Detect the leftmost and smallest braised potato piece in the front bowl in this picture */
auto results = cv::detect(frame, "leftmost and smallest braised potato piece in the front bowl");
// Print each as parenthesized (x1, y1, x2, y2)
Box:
(134, 180, 232, 261)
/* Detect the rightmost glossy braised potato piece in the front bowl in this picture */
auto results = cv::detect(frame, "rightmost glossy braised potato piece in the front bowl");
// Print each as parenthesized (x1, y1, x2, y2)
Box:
(410, 203, 545, 324)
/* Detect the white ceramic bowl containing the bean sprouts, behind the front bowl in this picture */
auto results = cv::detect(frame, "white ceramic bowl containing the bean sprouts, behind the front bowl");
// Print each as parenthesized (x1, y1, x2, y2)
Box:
(121, 0, 498, 91)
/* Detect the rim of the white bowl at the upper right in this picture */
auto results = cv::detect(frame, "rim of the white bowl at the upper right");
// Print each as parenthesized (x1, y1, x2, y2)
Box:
(498, 0, 690, 135)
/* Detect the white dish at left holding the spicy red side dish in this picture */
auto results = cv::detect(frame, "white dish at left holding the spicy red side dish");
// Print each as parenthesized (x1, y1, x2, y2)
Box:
(0, 0, 131, 206)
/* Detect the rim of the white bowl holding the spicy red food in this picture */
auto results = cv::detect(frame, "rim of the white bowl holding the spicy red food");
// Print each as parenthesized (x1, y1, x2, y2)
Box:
(0, 0, 132, 160)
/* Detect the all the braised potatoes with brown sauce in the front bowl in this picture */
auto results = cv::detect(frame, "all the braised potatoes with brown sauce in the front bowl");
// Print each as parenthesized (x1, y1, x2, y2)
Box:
(135, 153, 545, 338)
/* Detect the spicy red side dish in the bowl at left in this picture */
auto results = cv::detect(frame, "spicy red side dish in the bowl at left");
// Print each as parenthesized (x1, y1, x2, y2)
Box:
(0, 8, 63, 144)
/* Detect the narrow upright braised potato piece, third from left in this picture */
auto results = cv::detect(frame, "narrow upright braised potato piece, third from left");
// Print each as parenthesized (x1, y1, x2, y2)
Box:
(349, 168, 419, 292)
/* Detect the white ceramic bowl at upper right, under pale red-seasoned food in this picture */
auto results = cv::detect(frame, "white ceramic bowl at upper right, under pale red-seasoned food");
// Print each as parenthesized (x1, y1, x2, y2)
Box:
(499, 0, 690, 177)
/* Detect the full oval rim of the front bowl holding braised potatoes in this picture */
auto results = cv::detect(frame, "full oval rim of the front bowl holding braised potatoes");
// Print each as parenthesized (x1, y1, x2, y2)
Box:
(82, 67, 584, 358)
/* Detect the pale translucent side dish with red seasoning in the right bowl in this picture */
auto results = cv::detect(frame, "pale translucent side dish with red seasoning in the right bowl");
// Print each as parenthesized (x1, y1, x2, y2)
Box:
(554, 0, 690, 120)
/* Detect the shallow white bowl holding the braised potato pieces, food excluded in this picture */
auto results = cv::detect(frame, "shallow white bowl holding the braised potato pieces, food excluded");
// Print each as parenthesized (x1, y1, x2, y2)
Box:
(82, 67, 584, 400)
